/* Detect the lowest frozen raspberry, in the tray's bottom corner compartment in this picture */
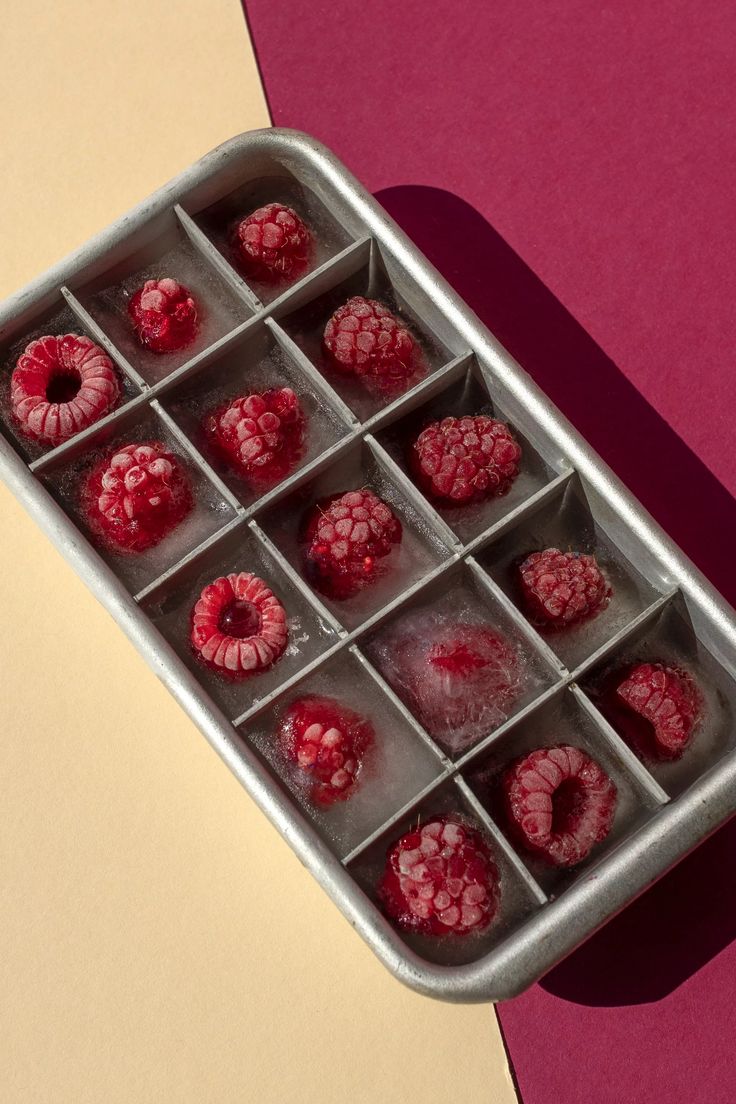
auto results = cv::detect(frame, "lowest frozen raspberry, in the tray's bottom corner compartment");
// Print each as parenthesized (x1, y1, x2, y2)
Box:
(378, 816, 500, 935)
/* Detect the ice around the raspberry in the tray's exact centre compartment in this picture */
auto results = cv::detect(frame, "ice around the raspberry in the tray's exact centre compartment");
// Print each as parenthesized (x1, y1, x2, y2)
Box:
(258, 442, 449, 629)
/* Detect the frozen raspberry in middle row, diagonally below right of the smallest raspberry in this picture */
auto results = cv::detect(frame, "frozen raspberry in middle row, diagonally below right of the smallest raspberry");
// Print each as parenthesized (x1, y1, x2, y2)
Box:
(204, 388, 305, 486)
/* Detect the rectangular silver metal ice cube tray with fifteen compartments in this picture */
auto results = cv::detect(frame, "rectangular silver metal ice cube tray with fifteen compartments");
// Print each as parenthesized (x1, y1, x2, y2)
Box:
(0, 130, 736, 1000)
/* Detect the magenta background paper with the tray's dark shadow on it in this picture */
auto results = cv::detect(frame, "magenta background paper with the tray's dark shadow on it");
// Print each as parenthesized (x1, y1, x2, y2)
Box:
(247, 0, 736, 1104)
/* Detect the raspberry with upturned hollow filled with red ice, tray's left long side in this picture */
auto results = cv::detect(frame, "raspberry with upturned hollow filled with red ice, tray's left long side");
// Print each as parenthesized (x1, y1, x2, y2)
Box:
(190, 571, 289, 678)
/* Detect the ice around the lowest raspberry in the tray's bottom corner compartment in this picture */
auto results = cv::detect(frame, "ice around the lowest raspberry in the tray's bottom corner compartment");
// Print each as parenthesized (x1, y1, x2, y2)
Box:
(348, 781, 540, 966)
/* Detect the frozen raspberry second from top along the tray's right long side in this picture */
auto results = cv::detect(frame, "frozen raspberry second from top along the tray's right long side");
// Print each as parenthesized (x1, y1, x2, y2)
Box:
(323, 295, 426, 394)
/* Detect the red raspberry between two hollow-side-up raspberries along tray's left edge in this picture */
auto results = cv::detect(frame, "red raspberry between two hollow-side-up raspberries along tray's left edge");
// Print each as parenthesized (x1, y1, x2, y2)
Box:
(82, 440, 192, 552)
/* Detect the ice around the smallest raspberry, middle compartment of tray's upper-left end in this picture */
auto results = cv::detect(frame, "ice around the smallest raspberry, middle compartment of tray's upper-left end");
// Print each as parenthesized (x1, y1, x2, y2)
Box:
(75, 214, 253, 384)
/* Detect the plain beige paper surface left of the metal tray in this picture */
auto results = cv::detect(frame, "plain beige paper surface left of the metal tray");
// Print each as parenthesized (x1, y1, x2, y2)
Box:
(0, 0, 515, 1104)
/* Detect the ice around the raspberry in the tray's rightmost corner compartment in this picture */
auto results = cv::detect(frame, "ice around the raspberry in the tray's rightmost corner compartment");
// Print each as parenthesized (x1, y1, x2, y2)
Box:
(582, 595, 736, 797)
